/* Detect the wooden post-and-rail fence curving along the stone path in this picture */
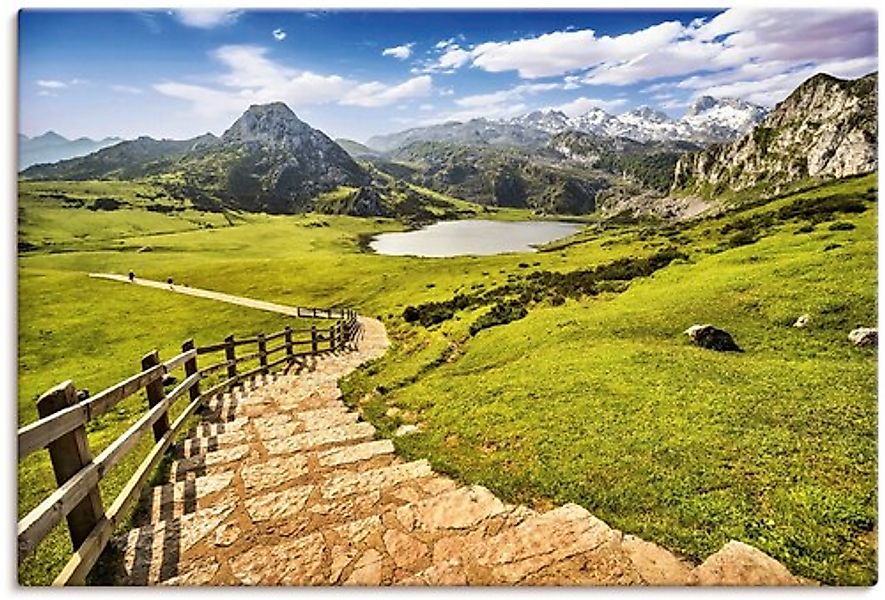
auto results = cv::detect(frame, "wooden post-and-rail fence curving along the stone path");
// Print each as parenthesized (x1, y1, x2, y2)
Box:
(18, 308, 360, 585)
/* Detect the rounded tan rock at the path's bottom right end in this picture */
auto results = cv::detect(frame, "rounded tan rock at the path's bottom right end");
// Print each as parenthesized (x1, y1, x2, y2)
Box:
(689, 540, 803, 586)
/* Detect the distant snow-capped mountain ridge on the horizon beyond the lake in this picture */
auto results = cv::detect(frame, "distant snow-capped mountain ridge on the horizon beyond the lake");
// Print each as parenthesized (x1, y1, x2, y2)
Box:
(368, 96, 766, 152)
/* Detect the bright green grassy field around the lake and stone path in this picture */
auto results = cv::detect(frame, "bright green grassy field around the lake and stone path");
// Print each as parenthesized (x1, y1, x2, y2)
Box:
(18, 176, 877, 585)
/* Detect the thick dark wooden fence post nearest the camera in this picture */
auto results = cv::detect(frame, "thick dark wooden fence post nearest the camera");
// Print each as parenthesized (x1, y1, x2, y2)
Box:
(37, 381, 104, 550)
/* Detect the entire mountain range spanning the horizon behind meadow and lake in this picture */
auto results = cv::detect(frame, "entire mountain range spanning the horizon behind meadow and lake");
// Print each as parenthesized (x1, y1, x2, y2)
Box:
(21, 73, 878, 220)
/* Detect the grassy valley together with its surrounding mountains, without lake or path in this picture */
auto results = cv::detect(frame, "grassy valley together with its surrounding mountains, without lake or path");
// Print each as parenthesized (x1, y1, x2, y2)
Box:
(17, 67, 878, 585)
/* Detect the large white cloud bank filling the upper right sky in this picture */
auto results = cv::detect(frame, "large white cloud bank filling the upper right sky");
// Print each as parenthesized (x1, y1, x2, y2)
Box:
(424, 8, 877, 109)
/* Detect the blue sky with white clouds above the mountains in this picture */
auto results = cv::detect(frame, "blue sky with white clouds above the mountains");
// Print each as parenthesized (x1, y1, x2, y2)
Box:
(19, 8, 878, 140)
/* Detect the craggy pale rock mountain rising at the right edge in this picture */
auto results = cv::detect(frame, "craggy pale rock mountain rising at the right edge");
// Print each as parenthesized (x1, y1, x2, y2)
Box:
(673, 73, 878, 197)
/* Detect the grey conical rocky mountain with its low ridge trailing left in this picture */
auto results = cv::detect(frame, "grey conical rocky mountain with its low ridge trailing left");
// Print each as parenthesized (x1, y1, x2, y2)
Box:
(22, 102, 371, 213)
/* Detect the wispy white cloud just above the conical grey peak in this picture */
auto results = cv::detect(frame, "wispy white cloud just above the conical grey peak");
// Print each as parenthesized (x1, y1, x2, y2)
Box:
(153, 46, 433, 117)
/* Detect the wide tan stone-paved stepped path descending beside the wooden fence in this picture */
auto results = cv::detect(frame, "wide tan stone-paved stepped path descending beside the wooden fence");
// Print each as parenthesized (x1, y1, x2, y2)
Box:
(112, 318, 809, 586)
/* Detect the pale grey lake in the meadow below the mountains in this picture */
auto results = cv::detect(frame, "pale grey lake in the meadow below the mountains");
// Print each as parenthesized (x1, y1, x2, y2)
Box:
(369, 219, 581, 257)
